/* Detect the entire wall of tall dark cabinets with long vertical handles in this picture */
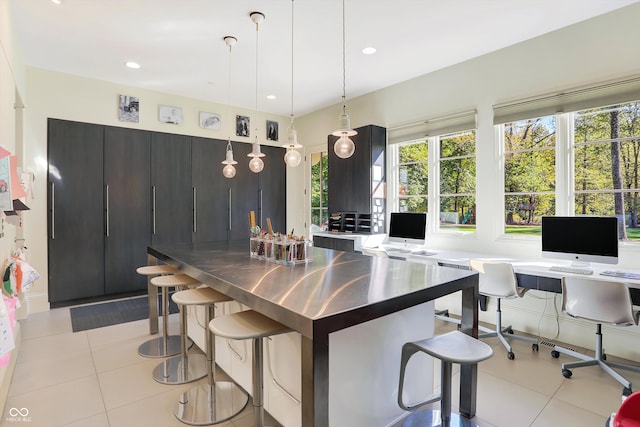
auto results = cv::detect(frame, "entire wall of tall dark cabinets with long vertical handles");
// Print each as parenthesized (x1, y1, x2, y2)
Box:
(48, 119, 286, 306)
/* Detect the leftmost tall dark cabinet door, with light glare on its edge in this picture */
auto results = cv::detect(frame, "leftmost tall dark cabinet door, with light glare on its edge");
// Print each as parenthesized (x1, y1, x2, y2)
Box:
(47, 119, 105, 304)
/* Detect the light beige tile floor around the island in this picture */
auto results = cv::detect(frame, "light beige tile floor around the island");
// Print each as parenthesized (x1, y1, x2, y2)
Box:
(0, 308, 640, 427)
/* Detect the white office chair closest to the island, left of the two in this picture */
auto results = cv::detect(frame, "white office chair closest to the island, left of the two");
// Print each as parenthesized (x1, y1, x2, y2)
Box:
(469, 259, 538, 360)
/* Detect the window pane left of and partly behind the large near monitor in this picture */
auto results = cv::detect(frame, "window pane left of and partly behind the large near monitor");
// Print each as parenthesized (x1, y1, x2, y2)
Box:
(504, 116, 556, 235)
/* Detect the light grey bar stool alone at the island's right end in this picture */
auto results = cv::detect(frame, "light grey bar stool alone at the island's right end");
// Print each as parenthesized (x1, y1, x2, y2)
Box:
(398, 330, 493, 427)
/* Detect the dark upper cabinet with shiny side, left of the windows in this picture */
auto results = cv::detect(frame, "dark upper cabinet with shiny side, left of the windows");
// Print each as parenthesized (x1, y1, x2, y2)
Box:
(327, 125, 387, 233)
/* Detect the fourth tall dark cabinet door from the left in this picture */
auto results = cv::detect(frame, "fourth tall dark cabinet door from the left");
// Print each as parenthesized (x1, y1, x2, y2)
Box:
(191, 137, 229, 242)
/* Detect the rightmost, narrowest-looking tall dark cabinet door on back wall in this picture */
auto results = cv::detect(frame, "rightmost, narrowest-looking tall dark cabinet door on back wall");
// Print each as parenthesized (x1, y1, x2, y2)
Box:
(257, 145, 286, 234)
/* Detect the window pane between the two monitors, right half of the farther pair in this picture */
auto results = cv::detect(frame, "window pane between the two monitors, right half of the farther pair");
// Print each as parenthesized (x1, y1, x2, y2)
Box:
(438, 131, 476, 232)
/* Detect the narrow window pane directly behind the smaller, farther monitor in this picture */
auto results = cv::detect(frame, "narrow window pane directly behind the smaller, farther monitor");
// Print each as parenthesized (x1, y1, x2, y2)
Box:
(392, 140, 429, 212)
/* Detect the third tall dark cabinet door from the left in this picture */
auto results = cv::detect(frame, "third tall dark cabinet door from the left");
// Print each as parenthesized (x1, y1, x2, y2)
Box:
(151, 133, 193, 244)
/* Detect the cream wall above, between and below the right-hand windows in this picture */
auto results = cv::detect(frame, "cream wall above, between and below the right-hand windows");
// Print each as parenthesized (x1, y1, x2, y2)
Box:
(297, 4, 640, 360)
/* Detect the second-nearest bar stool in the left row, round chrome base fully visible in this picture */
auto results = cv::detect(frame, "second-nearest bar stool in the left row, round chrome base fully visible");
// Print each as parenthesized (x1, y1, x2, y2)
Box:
(174, 296, 249, 426)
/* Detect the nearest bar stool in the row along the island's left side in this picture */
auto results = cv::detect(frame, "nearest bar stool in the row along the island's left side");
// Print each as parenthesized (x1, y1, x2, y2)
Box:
(209, 310, 291, 427)
